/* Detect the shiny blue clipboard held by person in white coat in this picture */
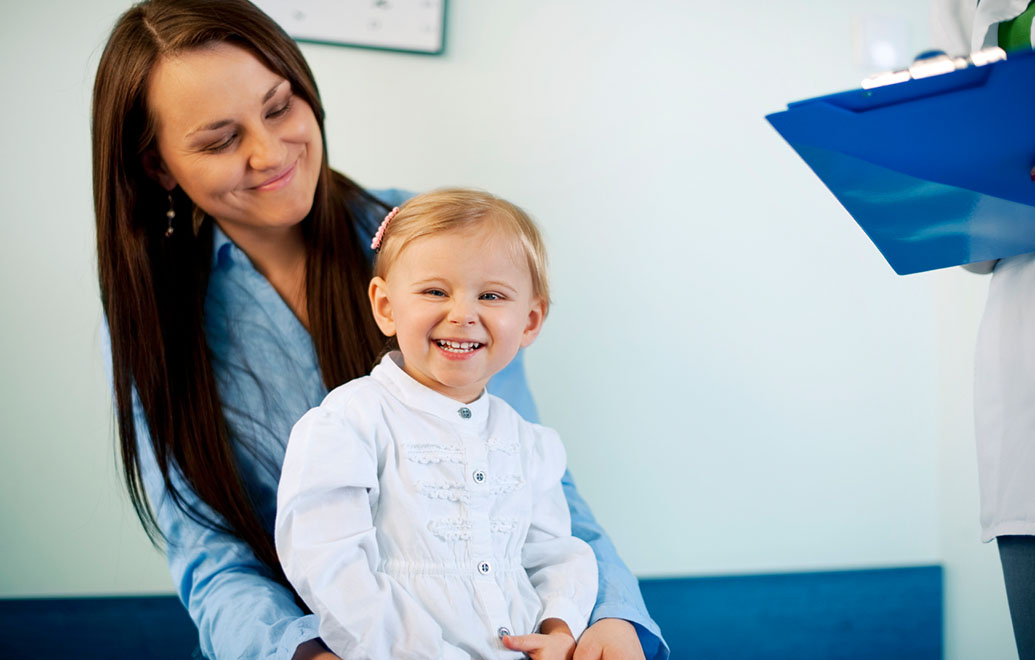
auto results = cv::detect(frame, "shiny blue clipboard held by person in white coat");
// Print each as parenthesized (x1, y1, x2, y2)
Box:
(766, 47, 1035, 275)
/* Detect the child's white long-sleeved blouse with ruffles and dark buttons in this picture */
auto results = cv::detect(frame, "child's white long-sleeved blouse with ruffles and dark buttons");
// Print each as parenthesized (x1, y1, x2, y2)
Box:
(275, 353, 597, 660)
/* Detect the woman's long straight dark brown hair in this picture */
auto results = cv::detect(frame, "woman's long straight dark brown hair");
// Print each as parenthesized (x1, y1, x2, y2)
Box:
(92, 0, 383, 583)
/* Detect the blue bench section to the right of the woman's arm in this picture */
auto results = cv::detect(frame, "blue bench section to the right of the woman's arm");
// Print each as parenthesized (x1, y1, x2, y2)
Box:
(640, 566, 942, 660)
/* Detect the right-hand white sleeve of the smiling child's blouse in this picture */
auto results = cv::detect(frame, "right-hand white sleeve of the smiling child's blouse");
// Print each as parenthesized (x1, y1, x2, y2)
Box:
(522, 426, 597, 639)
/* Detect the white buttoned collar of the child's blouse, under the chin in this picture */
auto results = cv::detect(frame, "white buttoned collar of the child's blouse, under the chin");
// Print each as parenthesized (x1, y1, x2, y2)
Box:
(371, 351, 489, 431)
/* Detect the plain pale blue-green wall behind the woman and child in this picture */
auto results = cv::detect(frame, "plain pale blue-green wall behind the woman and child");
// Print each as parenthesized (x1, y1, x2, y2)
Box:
(0, 0, 1015, 659)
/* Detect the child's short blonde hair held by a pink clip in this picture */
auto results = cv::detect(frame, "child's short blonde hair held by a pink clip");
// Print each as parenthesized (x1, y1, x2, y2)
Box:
(374, 188, 550, 312)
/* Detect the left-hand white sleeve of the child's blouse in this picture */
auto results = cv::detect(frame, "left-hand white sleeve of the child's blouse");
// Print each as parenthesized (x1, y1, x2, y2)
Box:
(275, 401, 470, 660)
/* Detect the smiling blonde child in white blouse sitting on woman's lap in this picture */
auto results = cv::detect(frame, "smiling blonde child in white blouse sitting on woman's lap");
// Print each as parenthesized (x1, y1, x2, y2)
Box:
(275, 189, 597, 660)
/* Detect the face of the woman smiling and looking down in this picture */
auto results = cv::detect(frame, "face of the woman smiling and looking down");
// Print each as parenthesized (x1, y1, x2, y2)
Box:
(148, 42, 323, 237)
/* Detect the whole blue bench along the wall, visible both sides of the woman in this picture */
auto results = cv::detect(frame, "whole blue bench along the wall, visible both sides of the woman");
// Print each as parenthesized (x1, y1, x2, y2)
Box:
(0, 566, 942, 660)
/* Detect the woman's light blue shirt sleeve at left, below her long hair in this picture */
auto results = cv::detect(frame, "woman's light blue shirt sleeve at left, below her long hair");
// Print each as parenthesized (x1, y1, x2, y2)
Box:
(101, 324, 318, 660)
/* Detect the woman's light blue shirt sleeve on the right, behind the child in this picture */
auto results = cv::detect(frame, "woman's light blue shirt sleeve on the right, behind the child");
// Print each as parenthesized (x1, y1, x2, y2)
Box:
(486, 352, 669, 660)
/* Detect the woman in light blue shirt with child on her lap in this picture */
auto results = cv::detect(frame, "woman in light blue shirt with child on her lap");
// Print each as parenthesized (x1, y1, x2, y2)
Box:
(93, 0, 668, 660)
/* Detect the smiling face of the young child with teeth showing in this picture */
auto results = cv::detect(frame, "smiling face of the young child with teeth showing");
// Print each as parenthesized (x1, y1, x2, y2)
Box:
(369, 227, 544, 403)
